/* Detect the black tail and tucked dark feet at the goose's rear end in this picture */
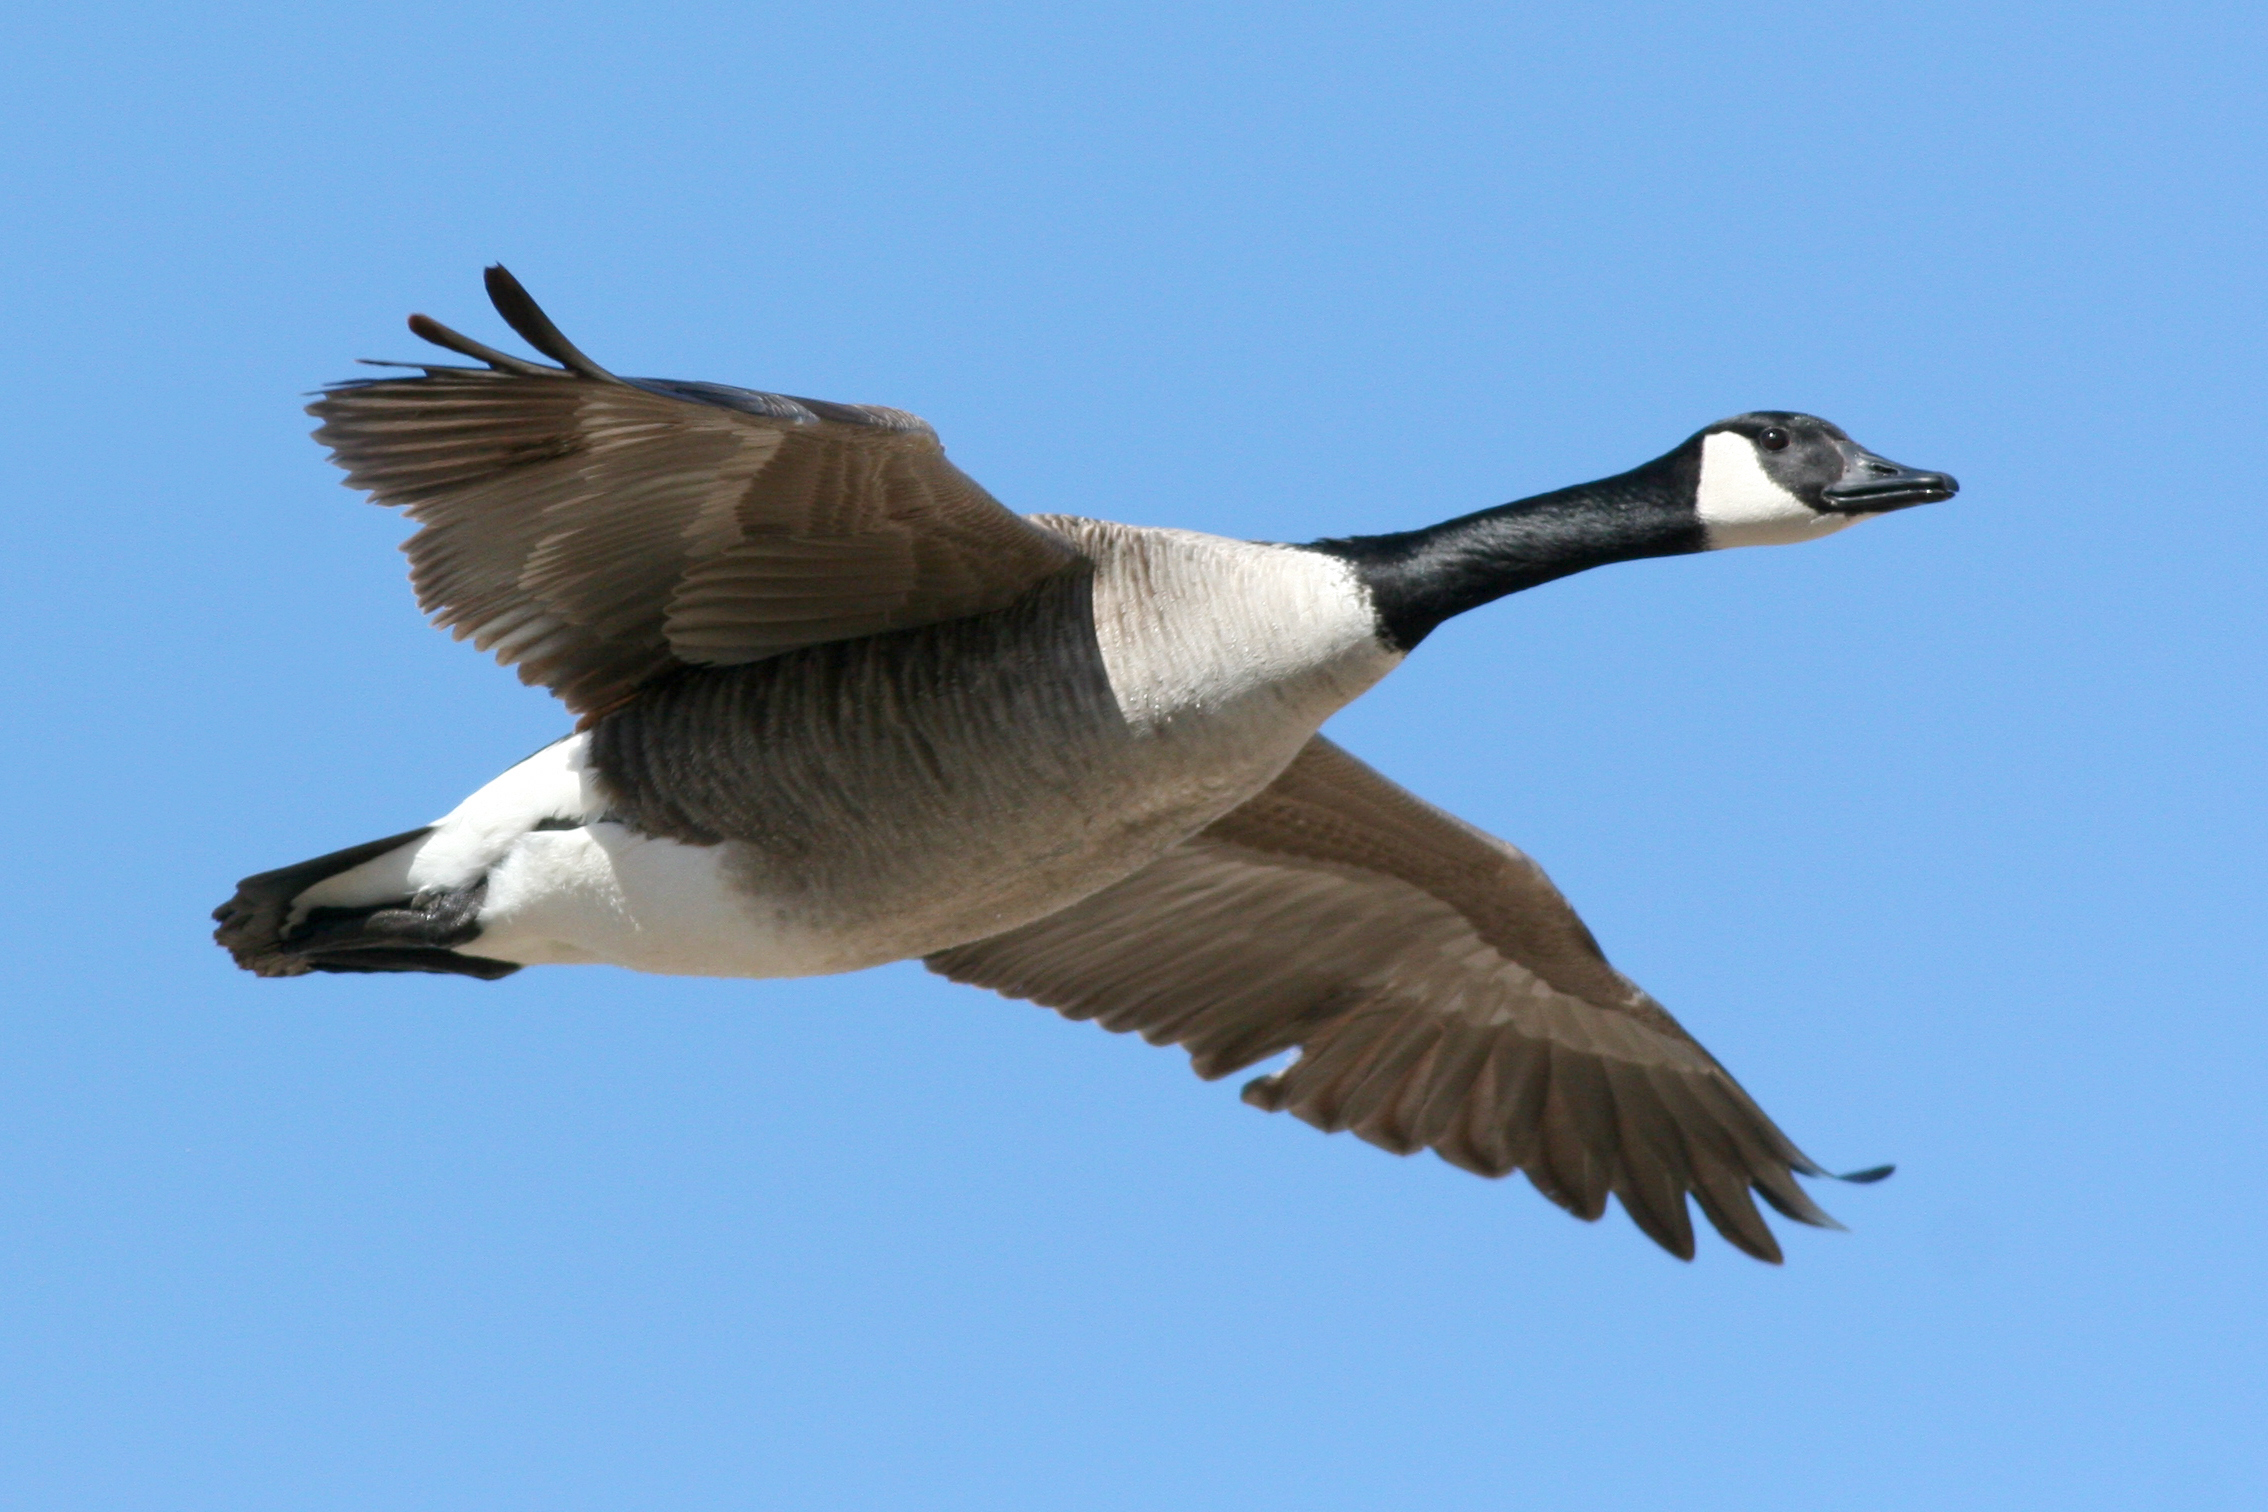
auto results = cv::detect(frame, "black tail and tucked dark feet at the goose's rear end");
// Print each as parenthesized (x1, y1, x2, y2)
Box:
(213, 825, 519, 982)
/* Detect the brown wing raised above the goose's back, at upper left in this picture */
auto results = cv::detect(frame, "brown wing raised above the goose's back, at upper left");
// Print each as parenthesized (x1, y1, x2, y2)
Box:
(308, 267, 1077, 714)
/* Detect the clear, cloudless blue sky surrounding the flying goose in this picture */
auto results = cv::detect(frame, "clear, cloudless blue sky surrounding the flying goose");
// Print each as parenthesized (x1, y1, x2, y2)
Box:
(0, 2, 2268, 1512)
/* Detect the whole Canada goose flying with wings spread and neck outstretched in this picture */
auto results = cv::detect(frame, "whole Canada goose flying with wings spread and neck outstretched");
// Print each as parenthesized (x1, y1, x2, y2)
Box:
(215, 265, 1957, 1263)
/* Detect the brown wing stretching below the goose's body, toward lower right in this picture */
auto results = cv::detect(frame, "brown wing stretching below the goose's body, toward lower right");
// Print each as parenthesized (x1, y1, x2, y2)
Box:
(928, 737, 1887, 1260)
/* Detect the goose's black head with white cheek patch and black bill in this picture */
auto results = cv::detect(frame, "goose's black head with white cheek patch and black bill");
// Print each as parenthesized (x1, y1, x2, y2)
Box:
(1681, 410, 1960, 549)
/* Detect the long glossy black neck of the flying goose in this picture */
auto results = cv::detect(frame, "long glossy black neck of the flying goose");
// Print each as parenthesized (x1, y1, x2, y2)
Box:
(1311, 447, 1708, 651)
